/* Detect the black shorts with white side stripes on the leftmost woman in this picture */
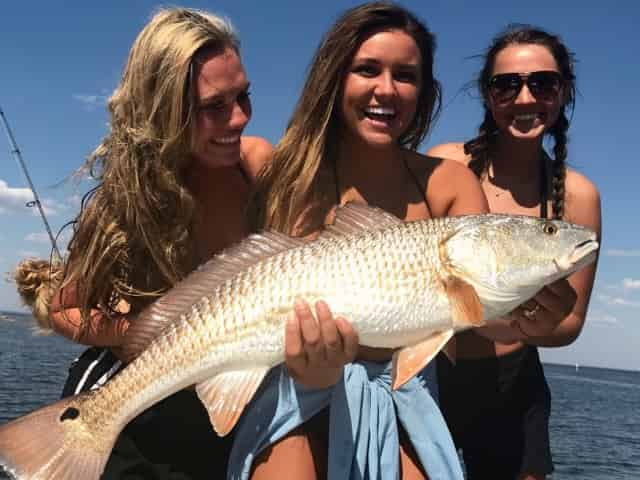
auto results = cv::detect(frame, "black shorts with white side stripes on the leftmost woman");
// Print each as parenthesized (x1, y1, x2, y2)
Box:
(63, 347, 233, 480)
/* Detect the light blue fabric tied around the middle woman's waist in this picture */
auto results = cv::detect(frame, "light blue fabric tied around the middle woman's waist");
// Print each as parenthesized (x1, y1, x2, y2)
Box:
(228, 361, 463, 480)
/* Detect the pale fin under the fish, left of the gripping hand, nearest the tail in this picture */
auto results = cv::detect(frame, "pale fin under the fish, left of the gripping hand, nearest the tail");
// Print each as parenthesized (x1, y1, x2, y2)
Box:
(196, 367, 269, 437)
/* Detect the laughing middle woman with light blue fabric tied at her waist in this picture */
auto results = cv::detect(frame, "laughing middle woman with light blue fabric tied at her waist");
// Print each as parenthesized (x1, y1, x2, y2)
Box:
(230, 2, 487, 479)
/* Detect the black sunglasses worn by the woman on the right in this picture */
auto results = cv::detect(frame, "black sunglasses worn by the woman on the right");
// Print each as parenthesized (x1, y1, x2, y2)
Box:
(488, 70, 564, 104)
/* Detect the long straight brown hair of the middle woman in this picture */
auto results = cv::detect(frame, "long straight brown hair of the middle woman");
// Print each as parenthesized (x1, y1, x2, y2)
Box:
(249, 2, 440, 233)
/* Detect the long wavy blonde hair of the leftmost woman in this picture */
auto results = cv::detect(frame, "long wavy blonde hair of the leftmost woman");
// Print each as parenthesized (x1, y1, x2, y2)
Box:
(18, 8, 239, 332)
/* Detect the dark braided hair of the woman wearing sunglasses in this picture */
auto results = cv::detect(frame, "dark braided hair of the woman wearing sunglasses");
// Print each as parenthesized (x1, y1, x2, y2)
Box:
(464, 25, 576, 218)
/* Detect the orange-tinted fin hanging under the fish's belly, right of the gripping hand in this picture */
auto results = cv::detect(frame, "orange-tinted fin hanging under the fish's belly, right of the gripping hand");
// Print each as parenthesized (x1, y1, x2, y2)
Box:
(391, 330, 453, 390)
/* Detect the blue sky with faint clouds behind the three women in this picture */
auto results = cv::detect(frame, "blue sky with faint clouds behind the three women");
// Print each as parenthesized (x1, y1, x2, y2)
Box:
(0, 0, 640, 370)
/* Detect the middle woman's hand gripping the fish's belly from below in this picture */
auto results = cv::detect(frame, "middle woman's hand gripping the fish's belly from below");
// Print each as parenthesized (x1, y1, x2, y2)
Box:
(285, 300, 358, 388)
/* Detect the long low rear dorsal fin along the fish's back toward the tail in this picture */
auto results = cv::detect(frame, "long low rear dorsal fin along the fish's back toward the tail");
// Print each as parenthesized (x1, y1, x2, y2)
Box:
(123, 232, 304, 361)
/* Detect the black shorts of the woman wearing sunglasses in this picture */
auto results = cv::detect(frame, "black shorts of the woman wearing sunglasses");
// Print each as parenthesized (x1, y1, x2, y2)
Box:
(437, 346, 553, 480)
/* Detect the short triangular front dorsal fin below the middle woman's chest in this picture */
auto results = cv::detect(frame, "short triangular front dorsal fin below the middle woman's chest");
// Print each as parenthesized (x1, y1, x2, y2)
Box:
(318, 202, 402, 238)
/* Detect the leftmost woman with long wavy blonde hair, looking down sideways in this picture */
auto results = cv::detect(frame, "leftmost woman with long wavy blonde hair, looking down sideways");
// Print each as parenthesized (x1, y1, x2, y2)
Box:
(17, 8, 271, 479)
